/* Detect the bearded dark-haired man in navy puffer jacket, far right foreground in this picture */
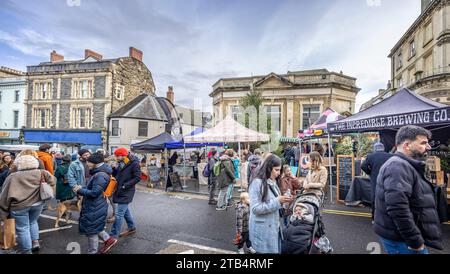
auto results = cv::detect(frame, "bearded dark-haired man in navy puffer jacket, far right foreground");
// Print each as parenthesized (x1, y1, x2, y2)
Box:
(374, 126, 443, 254)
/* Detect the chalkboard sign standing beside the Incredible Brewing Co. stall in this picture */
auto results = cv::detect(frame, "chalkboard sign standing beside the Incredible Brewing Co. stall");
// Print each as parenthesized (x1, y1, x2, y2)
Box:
(337, 155, 355, 203)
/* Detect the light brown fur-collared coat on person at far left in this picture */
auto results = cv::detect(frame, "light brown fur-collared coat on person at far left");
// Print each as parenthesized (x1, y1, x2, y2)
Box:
(0, 164, 56, 218)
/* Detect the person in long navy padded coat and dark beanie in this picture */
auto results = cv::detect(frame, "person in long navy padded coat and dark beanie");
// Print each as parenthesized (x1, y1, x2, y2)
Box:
(74, 153, 117, 254)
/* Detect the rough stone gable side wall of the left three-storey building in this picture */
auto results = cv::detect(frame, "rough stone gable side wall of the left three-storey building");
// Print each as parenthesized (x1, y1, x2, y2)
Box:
(111, 57, 155, 112)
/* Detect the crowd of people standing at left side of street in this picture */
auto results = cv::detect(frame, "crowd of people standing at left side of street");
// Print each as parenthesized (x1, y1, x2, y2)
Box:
(0, 144, 141, 254)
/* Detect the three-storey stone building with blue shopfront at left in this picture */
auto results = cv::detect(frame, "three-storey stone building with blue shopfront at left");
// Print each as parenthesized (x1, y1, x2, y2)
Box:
(24, 47, 155, 152)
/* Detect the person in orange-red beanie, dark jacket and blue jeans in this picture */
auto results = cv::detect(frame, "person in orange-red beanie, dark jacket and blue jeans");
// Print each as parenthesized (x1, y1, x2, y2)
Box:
(105, 148, 141, 248)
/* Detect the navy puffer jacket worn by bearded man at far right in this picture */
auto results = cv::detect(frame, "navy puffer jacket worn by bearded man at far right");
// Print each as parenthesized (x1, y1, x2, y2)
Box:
(374, 152, 443, 250)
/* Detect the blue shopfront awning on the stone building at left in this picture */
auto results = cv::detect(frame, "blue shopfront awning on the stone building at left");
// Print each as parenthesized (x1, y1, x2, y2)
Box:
(24, 130, 102, 145)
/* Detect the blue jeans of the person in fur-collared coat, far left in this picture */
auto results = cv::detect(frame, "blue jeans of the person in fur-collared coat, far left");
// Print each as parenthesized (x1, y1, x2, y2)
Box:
(11, 204, 44, 253)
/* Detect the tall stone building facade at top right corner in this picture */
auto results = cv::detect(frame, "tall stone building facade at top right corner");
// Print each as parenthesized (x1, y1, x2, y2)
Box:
(389, 0, 450, 104)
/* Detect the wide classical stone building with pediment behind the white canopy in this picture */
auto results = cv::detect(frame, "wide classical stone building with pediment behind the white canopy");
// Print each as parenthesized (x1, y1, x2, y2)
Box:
(210, 69, 360, 137)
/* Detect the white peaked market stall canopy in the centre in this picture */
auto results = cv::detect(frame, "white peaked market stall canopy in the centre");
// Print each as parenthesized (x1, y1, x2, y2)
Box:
(184, 116, 270, 143)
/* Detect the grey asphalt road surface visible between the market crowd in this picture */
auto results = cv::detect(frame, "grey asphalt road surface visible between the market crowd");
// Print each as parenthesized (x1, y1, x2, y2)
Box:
(6, 186, 450, 254)
